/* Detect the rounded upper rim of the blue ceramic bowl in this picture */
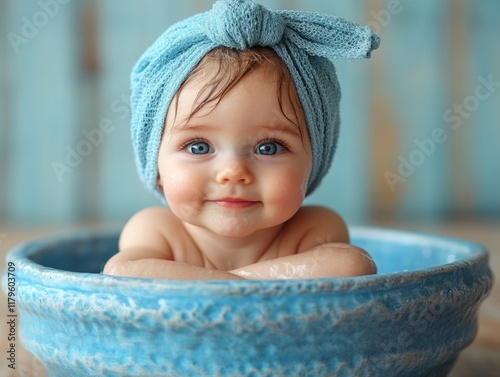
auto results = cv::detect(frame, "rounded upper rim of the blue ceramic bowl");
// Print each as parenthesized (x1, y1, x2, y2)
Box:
(4, 226, 489, 296)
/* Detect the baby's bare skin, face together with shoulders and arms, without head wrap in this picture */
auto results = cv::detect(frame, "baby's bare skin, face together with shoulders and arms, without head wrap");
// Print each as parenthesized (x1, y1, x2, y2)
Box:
(104, 56, 377, 280)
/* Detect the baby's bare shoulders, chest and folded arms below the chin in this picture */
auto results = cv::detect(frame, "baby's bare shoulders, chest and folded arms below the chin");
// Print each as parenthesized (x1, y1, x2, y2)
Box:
(104, 207, 377, 280)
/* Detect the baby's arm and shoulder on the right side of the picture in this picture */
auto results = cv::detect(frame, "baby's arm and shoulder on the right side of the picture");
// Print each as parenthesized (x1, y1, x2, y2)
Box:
(230, 207, 377, 280)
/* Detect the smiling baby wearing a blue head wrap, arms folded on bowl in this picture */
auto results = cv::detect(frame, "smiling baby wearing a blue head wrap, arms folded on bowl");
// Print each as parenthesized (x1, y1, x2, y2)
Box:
(104, 0, 379, 280)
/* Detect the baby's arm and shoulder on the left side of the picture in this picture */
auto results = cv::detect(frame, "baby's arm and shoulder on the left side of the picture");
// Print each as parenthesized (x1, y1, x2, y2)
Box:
(103, 208, 244, 280)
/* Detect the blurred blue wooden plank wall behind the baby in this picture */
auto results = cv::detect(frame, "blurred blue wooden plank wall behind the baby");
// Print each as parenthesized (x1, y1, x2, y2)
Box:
(0, 0, 500, 226)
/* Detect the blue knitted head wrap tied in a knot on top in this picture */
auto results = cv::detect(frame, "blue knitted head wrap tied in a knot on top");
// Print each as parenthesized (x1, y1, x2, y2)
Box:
(131, 0, 379, 195)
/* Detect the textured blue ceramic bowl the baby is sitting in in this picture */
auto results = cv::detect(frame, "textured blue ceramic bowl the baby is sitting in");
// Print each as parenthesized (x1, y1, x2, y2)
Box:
(4, 228, 492, 377)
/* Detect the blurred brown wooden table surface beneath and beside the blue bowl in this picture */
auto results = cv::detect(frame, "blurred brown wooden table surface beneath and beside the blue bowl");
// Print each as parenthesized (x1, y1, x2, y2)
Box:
(0, 221, 500, 377)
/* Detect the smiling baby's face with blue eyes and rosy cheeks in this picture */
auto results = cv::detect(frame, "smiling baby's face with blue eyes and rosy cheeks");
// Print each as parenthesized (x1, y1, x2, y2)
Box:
(158, 62, 312, 237)
